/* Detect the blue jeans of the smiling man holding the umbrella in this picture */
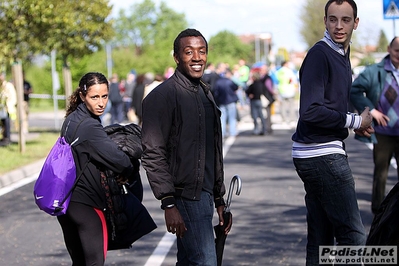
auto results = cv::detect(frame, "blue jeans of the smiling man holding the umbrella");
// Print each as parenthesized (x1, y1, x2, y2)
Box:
(176, 191, 217, 266)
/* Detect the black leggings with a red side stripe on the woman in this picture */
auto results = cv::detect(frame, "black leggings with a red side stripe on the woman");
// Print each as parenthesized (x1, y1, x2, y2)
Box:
(57, 202, 108, 266)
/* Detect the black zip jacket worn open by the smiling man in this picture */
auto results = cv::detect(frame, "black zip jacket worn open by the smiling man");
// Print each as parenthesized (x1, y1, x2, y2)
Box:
(142, 69, 225, 207)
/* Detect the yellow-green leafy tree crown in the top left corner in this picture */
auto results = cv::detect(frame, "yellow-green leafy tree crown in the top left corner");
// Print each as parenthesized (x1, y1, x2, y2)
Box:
(0, 0, 113, 68)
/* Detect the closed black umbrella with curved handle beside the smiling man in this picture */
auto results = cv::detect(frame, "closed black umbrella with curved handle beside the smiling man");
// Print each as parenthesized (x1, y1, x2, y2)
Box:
(213, 175, 241, 266)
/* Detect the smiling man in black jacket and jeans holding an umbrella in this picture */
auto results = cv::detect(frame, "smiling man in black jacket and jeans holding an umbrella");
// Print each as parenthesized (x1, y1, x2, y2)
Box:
(142, 29, 231, 266)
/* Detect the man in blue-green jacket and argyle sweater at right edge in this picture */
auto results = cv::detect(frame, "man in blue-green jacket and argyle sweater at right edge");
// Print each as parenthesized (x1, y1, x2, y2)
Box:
(351, 37, 399, 214)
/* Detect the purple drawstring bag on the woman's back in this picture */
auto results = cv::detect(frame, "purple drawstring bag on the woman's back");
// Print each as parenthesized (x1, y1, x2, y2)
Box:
(33, 137, 77, 216)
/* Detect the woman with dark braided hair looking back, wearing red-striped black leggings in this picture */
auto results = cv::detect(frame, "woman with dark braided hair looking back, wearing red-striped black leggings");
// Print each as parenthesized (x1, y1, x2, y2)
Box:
(57, 72, 133, 265)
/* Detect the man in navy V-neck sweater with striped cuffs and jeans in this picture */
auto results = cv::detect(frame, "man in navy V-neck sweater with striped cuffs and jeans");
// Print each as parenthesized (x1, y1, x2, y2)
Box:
(292, 0, 373, 265)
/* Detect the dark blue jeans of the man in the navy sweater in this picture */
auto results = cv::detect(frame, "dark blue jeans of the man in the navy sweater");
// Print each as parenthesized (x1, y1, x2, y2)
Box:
(293, 154, 366, 266)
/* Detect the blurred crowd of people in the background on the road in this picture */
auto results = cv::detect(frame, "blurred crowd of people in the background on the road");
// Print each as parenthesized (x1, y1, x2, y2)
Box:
(103, 59, 299, 138)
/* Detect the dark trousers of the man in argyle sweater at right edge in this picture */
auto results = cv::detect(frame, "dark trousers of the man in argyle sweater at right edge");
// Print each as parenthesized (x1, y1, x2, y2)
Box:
(371, 133, 399, 213)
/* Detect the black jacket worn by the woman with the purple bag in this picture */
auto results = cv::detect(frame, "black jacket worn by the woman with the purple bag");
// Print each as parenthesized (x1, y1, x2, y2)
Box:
(61, 103, 133, 210)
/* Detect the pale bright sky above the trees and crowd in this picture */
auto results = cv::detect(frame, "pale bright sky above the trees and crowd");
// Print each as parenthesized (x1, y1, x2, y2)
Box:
(110, 0, 399, 51)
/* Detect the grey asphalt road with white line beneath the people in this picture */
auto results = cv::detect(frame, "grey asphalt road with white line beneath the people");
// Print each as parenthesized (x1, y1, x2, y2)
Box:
(0, 107, 396, 266)
